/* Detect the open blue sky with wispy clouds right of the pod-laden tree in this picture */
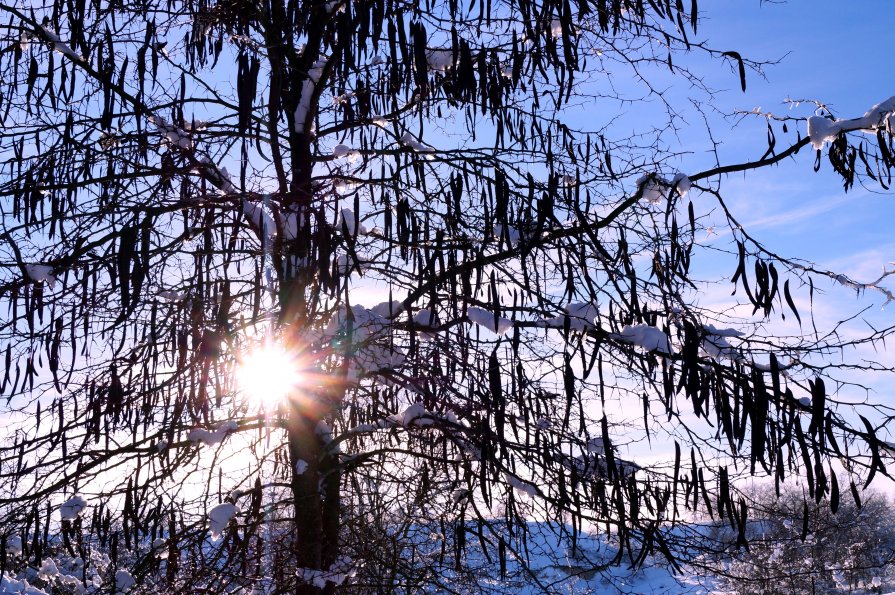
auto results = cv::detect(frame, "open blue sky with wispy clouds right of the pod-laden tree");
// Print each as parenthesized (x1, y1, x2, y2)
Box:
(569, 0, 895, 456)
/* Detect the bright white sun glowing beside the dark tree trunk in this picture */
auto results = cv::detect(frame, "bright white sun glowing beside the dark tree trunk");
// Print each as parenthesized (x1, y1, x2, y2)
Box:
(236, 341, 302, 406)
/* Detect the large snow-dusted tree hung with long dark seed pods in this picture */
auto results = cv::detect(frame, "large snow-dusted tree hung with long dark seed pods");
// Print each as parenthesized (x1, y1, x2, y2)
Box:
(0, 0, 895, 593)
